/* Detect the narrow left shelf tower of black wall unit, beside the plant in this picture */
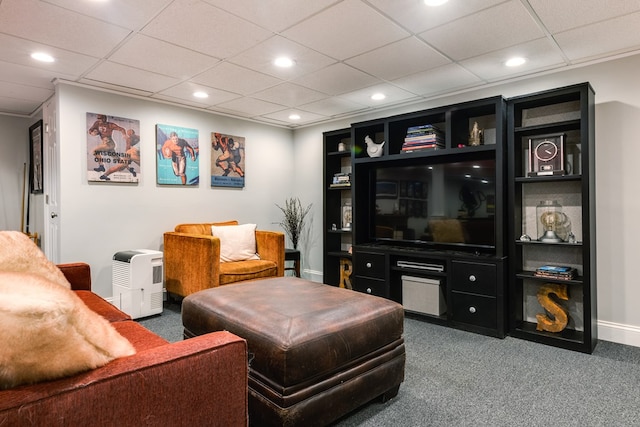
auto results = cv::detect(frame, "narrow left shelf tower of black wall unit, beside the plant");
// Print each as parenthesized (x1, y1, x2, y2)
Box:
(323, 128, 353, 286)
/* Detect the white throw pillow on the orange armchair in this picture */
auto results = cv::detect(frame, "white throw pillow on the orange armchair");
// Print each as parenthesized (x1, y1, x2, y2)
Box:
(211, 224, 260, 262)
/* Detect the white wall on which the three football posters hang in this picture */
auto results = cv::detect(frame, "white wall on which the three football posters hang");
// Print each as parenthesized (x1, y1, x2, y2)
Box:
(58, 85, 294, 297)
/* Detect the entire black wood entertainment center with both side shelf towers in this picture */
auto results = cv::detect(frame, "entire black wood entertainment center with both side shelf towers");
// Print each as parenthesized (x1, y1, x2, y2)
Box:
(323, 83, 597, 353)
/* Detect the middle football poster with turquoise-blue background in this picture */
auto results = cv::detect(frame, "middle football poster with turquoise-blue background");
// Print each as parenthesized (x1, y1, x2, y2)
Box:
(156, 124, 200, 186)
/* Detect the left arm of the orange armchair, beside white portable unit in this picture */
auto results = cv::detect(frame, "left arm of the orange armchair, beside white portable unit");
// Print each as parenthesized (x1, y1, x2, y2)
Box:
(164, 231, 220, 297)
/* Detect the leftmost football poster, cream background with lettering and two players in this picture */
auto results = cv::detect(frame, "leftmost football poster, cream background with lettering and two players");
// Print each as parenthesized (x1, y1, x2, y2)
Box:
(87, 113, 141, 183)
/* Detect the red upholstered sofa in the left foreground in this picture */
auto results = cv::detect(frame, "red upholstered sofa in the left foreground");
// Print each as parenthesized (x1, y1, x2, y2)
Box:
(0, 263, 248, 427)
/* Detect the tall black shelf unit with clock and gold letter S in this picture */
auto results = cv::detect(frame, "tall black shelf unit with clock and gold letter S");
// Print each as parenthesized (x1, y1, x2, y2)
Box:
(507, 83, 597, 353)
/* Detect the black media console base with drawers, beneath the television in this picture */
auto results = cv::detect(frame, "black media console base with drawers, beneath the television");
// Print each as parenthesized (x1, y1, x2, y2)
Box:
(353, 244, 507, 338)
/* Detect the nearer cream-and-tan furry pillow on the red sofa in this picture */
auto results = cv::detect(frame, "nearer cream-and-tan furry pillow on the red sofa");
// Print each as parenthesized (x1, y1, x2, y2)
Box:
(0, 271, 135, 389)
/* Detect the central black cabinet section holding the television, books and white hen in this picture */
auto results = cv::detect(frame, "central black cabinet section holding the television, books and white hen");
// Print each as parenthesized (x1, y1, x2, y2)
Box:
(351, 96, 507, 337)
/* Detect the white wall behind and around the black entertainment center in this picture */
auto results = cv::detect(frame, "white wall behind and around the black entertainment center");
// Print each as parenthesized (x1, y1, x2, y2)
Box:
(294, 55, 640, 346)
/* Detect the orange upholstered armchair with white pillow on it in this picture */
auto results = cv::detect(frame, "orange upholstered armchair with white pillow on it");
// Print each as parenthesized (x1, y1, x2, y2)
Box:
(164, 221, 284, 297)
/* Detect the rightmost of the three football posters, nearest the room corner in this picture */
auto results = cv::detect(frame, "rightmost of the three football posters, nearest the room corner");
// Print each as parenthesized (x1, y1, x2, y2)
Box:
(211, 132, 245, 188)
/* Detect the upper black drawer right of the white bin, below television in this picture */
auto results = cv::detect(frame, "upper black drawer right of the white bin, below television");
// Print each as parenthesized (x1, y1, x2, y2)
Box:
(451, 260, 497, 296)
